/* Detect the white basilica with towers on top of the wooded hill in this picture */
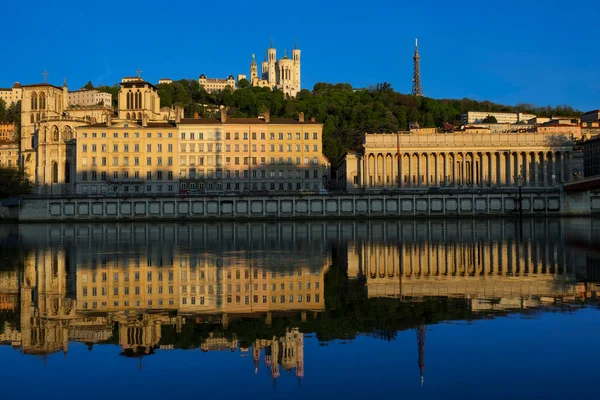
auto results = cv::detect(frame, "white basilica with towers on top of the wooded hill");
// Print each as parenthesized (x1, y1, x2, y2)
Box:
(250, 42, 301, 97)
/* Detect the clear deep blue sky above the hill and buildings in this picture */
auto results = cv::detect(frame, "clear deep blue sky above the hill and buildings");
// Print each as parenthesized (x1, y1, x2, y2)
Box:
(0, 0, 600, 111)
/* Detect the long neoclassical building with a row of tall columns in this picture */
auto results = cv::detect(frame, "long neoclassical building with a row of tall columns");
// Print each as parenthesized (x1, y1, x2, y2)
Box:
(339, 130, 583, 191)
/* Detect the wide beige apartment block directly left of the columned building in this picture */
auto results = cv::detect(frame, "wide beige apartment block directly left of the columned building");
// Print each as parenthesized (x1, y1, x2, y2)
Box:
(178, 109, 329, 192)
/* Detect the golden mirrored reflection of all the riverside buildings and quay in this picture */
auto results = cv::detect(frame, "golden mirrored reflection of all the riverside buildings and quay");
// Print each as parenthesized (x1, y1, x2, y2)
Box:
(0, 220, 600, 381)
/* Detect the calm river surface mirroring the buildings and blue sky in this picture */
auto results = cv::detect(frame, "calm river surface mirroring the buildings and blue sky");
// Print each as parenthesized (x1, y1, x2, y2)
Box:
(0, 219, 600, 399)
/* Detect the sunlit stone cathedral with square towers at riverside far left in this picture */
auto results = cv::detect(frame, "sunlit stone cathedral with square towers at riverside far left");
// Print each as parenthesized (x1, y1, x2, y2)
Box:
(21, 74, 183, 195)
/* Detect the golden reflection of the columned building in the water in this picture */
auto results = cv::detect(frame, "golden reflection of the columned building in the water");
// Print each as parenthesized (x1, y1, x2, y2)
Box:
(348, 236, 579, 297)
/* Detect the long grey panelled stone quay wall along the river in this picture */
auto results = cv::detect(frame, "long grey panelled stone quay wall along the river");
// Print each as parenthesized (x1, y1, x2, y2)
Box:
(19, 191, 600, 222)
